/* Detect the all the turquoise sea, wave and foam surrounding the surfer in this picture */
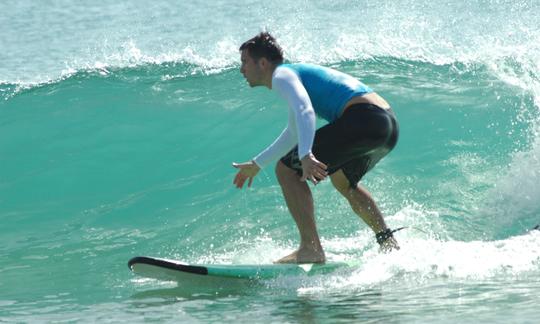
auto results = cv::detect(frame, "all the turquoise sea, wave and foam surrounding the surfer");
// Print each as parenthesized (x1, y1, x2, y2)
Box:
(0, 0, 540, 323)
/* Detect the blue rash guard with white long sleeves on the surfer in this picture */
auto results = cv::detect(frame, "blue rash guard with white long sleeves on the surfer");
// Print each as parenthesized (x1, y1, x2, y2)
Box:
(253, 63, 373, 168)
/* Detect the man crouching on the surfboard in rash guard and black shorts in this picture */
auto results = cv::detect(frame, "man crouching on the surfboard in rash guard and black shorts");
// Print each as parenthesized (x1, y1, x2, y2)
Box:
(233, 32, 399, 263)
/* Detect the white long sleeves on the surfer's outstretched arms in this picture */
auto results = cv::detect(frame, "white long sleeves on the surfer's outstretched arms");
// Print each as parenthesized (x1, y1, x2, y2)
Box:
(253, 66, 315, 168)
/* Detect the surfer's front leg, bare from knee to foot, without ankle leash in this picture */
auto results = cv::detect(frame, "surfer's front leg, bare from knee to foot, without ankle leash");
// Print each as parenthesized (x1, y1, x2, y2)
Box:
(276, 161, 325, 263)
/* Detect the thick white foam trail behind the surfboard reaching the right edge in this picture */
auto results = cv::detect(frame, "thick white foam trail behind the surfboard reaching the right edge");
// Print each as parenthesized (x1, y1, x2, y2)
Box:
(297, 231, 540, 294)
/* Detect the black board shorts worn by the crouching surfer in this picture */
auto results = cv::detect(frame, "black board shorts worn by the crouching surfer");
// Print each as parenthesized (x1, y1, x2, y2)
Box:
(281, 103, 399, 188)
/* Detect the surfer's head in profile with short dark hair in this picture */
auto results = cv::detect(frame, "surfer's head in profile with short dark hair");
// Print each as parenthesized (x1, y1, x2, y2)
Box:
(239, 32, 283, 87)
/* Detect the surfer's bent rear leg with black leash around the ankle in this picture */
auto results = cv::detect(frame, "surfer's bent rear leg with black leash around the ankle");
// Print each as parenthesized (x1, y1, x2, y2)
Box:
(330, 170, 399, 251)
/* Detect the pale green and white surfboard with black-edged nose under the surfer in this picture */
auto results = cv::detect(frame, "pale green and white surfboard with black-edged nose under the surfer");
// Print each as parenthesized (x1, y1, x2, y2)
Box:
(128, 256, 354, 282)
